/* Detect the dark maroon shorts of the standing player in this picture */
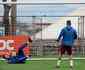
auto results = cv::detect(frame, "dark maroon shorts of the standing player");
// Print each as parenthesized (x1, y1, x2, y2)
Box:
(59, 45, 72, 55)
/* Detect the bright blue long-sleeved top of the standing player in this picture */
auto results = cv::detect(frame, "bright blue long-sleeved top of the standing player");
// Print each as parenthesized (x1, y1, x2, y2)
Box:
(58, 27, 77, 46)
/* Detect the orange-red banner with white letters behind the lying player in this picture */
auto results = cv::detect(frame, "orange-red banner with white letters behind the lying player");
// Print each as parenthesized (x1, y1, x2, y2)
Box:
(0, 35, 31, 56)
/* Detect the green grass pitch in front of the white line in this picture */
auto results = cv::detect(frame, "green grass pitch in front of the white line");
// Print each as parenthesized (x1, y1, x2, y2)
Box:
(0, 60, 85, 70)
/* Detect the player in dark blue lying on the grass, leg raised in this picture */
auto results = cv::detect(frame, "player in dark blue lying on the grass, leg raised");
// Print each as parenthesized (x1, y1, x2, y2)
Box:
(5, 43, 27, 64)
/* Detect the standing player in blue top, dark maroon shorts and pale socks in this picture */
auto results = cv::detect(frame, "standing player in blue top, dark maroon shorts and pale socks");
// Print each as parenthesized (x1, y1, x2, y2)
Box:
(57, 20, 77, 67)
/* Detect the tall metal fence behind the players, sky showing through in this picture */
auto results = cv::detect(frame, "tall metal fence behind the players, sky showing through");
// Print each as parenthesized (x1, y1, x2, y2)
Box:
(0, 3, 85, 56)
